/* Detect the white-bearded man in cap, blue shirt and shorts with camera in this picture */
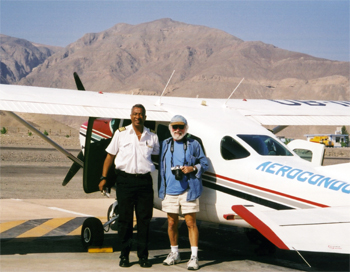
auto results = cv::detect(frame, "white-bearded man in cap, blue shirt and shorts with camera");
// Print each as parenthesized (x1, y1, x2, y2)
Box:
(159, 115, 208, 270)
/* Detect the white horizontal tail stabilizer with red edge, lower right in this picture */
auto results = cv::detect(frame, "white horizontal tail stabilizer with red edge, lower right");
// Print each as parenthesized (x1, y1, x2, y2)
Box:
(232, 205, 350, 254)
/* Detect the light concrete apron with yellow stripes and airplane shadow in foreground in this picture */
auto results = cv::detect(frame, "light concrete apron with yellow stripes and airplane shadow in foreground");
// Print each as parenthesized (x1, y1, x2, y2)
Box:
(0, 198, 349, 272)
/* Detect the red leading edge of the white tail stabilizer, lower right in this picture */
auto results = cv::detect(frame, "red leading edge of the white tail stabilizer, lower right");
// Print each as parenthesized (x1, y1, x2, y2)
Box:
(232, 205, 289, 250)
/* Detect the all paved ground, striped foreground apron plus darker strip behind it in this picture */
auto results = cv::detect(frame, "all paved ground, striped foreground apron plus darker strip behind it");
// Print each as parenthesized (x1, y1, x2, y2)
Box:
(0, 147, 350, 272)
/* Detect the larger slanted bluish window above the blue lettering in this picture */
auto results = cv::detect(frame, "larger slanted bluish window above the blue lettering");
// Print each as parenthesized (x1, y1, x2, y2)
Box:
(237, 135, 293, 156)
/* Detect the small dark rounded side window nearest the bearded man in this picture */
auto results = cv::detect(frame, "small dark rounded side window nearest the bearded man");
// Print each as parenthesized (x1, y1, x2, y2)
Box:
(220, 136, 250, 160)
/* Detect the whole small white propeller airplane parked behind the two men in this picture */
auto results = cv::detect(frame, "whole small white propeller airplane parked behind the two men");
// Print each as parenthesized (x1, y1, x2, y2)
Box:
(0, 74, 350, 260)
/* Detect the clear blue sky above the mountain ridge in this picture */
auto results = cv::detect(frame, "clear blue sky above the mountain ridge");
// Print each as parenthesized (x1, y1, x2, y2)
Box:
(0, 0, 350, 61)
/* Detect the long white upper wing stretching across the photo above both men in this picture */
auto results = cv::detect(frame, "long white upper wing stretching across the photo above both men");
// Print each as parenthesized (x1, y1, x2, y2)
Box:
(0, 84, 350, 126)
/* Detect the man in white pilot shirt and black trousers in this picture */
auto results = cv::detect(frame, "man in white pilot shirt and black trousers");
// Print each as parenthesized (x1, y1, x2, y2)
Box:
(99, 104, 159, 267)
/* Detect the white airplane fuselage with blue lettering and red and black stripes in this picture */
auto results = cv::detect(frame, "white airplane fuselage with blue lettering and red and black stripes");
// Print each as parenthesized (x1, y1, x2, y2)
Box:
(81, 118, 350, 230)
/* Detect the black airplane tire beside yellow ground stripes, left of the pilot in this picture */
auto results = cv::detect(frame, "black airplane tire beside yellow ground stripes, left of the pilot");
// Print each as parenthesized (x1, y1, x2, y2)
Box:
(81, 217, 104, 248)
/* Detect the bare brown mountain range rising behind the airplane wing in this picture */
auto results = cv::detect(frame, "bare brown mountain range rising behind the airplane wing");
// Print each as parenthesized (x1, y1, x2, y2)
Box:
(0, 18, 350, 100)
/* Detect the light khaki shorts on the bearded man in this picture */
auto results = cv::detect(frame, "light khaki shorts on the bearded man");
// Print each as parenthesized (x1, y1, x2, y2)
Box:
(162, 191, 199, 214)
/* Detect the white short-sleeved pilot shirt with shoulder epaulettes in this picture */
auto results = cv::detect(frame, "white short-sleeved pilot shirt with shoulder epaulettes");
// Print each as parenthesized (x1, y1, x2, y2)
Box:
(106, 124, 159, 174)
